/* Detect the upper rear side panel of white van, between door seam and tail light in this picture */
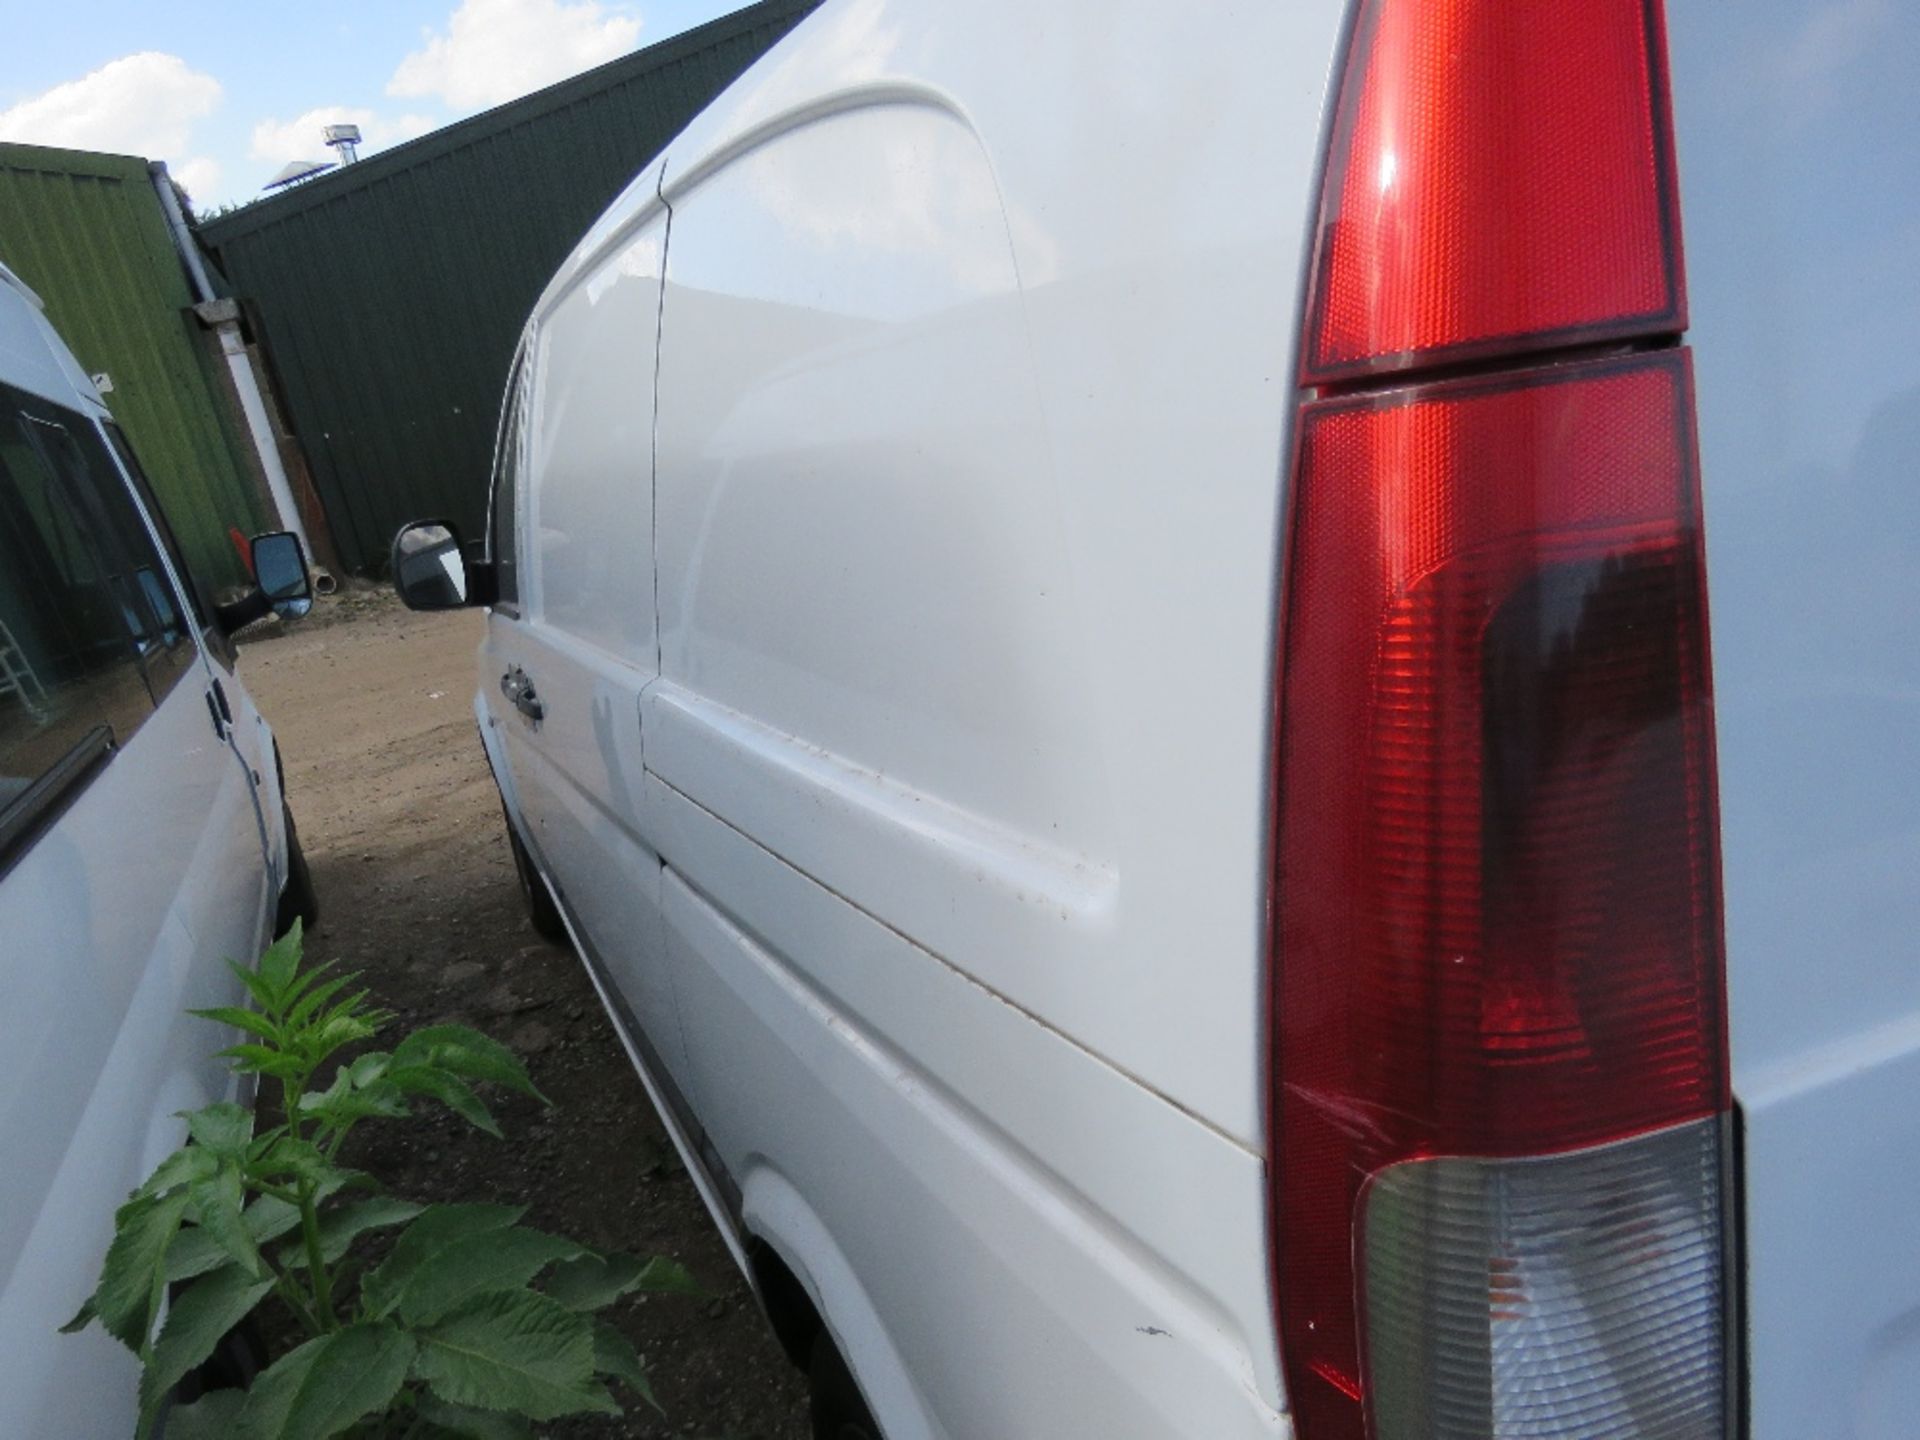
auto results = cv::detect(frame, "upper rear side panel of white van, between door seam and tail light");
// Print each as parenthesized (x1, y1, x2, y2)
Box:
(649, 0, 1342, 1150)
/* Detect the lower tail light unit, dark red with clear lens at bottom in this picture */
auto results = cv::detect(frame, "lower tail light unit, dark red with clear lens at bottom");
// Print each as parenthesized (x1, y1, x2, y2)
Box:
(1273, 349, 1730, 1440)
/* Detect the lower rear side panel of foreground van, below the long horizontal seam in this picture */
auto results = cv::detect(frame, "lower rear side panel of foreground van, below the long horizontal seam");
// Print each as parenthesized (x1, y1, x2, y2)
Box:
(649, 781, 1279, 1436)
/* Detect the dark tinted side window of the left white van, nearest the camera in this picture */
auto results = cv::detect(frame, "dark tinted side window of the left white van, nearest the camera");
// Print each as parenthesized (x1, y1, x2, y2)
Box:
(0, 386, 180, 862)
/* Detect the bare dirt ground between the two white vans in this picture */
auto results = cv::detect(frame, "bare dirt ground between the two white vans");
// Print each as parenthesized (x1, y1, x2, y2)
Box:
(240, 589, 808, 1440)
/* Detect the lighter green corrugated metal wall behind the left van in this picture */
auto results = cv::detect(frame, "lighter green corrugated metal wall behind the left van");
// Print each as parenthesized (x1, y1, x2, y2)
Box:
(0, 144, 271, 588)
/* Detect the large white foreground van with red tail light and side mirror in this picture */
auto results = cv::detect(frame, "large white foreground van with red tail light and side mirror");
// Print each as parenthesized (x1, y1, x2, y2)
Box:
(396, 0, 1920, 1440)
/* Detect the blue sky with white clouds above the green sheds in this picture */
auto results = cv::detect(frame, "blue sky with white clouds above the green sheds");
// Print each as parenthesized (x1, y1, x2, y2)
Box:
(0, 0, 743, 209)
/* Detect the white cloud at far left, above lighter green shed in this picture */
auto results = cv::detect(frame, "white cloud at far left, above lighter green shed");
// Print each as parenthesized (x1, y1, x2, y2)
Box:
(0, 50, 221, 159)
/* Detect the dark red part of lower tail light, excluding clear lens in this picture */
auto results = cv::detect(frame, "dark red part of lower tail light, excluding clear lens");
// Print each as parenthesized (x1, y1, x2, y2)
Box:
(1275, 351, 1728, 1440)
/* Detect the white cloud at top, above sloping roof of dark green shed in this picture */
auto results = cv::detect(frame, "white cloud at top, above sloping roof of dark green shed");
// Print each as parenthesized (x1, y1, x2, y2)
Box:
(386, 0, 639, 109)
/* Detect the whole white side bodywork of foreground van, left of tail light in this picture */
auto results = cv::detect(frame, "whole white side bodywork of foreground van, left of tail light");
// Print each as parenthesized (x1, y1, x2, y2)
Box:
(478, 0, 1342, 1440)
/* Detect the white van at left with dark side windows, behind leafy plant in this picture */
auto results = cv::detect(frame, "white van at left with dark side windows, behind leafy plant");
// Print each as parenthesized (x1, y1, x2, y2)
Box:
(0, 253, 313, 1440)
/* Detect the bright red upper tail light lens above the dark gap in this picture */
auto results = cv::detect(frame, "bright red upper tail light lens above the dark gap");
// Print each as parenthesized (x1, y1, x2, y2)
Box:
(1302, 0, 1686, 382)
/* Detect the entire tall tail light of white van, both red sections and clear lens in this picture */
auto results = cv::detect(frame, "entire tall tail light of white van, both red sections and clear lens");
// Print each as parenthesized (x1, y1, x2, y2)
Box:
(1269, 0, 1732, 1440)
